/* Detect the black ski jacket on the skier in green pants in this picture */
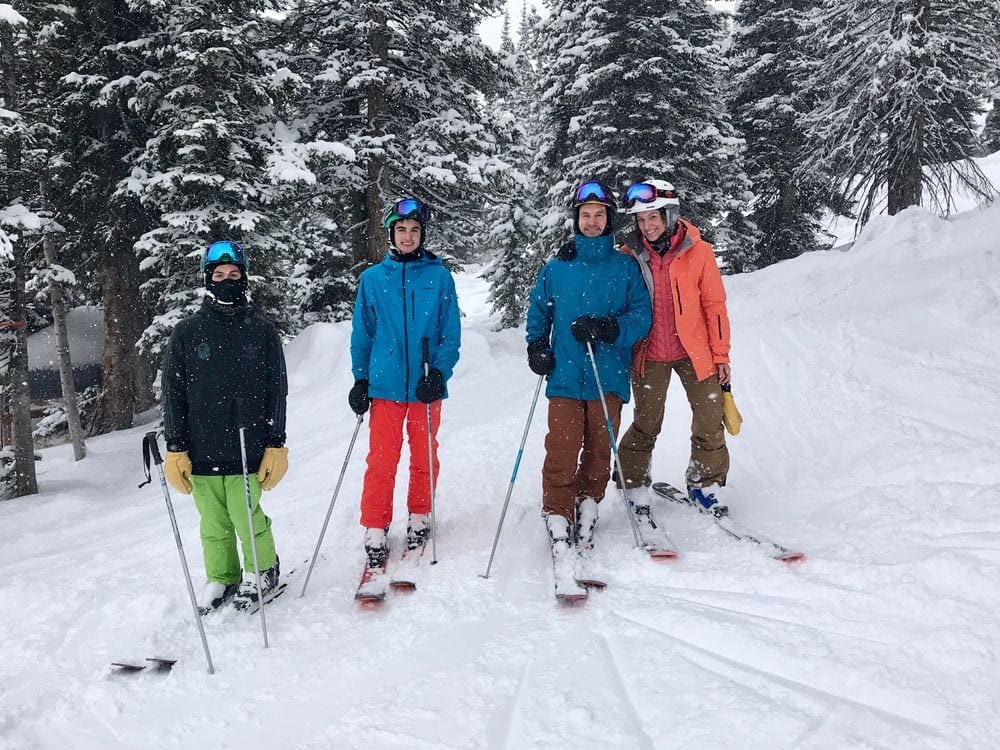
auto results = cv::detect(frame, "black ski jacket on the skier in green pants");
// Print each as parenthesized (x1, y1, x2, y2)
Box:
(162, 300, 288, 475)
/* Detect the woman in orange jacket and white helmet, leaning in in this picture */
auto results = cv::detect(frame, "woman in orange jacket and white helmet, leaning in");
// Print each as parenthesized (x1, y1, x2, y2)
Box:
(618, 180, 730, 512)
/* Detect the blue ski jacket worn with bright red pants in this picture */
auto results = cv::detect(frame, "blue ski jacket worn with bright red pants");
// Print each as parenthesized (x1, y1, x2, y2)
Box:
(351, 250, 461, 402)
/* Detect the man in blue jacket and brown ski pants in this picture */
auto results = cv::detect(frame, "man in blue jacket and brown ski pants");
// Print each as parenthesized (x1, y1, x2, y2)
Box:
(527, 181, 652, 588)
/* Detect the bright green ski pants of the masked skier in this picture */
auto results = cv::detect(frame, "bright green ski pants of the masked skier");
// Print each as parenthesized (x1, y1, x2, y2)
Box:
(191, 474, 277, 584)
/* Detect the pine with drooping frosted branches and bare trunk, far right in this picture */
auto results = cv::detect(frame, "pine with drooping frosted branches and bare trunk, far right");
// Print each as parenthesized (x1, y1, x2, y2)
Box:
(803, 0, 1000, 226)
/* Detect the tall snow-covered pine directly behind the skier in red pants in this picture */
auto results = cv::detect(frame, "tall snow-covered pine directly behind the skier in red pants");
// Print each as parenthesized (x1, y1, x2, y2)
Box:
(291, 0, 506, 264)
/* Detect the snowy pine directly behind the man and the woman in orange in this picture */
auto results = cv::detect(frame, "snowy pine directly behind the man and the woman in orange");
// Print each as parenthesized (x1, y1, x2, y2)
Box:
(534, 0, 750, 262)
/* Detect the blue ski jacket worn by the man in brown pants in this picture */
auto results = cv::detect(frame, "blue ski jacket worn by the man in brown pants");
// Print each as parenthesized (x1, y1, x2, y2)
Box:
(527, 234, 652, 403)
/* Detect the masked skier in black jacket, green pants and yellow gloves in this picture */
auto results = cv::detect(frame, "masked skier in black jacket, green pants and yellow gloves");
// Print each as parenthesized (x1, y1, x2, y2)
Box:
(162, 240, 288, 612)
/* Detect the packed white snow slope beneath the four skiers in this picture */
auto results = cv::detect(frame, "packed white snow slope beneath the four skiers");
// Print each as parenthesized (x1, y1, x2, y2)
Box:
(0, 200, 1000, 750)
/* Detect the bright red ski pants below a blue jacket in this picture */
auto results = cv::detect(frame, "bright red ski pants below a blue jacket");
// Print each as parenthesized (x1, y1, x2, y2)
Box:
(361, 398, 441, 529)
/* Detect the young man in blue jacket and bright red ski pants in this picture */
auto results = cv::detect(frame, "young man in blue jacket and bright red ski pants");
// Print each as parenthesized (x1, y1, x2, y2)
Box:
(348, 198, 461, 568)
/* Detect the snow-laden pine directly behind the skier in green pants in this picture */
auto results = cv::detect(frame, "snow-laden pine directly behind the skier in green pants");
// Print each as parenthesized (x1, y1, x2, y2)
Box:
(128, 0, 291, 357)
